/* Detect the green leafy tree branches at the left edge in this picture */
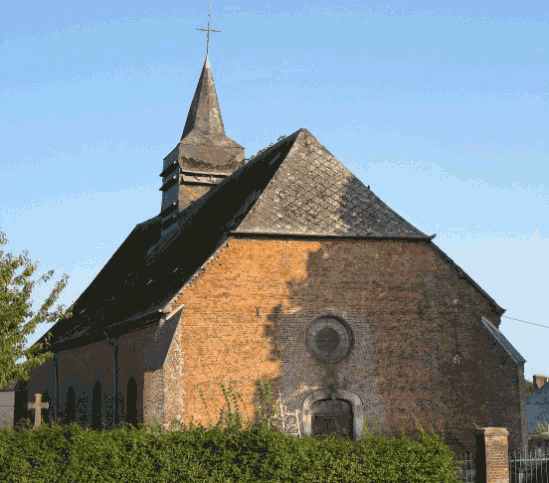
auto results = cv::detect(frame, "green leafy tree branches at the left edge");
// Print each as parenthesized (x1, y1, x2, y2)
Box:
(0, 230, 72, 388)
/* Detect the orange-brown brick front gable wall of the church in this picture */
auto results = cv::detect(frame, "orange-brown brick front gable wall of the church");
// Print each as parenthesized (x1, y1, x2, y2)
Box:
(168, 238, 526, 458)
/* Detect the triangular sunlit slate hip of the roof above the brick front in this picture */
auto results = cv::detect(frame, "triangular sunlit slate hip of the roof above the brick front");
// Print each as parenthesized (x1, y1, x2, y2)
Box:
(236, 129, 428, 238)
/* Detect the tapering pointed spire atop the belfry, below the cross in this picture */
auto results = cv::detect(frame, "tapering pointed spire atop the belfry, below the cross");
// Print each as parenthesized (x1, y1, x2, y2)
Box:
(181, 55, 225, 139)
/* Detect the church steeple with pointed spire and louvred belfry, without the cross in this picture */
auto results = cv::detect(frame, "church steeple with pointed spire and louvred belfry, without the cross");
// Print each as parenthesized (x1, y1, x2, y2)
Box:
(160, 54, 245, 235)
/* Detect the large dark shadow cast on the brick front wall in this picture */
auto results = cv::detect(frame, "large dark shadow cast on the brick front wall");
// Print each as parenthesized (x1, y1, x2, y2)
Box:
(244, 174, 510, 451)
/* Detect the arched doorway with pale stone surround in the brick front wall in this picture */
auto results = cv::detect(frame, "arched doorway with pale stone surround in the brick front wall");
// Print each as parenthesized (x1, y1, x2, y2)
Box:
(311, 398, 354, 438)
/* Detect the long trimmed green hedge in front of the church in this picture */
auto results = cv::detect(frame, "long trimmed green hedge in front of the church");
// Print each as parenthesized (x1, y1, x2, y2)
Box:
(0, 421, 461, 483)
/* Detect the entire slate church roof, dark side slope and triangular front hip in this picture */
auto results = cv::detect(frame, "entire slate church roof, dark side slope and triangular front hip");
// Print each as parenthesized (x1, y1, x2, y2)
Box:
(32, 129, 506, 352)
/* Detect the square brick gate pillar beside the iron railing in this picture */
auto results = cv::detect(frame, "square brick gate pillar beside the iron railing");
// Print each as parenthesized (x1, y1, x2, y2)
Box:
(475, 428, 509, 483)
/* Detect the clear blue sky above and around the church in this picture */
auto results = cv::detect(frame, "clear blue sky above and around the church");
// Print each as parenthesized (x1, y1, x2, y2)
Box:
(0, 0, 549, 379)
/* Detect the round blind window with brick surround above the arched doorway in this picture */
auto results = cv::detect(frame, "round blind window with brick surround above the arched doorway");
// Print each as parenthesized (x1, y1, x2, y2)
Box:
(307, 317, 351, 363)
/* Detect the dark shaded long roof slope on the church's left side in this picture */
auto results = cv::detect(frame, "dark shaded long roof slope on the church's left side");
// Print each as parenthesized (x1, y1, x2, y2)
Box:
(36, 132, 295, 351)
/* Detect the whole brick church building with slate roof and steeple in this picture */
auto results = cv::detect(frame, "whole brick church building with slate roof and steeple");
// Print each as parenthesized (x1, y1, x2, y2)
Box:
(14, 56, 527, 458)
